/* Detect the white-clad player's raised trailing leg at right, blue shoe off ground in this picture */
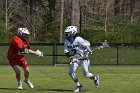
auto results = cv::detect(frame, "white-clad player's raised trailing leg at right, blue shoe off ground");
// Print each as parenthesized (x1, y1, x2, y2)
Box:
(81, 59, 99, 87)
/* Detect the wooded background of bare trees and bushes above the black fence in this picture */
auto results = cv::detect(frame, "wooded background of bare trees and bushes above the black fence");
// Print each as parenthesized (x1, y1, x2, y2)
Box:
(0, 0, 140, 42)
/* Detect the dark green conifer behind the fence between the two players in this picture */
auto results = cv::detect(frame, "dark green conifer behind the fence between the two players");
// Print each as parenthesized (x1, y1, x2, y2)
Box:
(37, 12, 58, 42)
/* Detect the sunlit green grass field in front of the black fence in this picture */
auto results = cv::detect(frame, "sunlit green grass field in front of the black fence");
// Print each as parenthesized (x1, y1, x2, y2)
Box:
(0, 65, 140, 93)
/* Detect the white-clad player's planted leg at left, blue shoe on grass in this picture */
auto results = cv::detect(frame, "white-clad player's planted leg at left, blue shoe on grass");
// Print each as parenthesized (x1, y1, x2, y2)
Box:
(69, 62, 82, 92)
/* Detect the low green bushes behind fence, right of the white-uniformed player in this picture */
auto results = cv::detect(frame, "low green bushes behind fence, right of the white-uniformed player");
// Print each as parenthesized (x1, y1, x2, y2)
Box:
(82, 22, 140, 43)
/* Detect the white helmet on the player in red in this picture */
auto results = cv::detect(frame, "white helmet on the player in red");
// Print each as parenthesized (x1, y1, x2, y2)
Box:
(17, 28, 30, 40)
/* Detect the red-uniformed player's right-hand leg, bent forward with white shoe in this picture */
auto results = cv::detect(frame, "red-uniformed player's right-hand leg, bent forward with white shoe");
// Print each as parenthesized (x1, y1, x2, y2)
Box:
(22, 62, 34, 88)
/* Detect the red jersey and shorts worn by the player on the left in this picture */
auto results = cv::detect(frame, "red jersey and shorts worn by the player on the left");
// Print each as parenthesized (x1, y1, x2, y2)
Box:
(7, 36, 30, 66)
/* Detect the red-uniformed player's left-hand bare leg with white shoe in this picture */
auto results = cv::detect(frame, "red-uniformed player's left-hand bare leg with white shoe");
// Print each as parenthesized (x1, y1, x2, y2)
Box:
(12, 65, 23, 89)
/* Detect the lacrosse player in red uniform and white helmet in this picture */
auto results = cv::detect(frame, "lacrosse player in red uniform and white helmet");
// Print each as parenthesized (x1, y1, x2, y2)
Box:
(7, 28, 43, 90)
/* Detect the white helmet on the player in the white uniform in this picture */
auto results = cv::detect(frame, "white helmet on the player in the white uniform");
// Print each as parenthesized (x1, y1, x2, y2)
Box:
(64, 26, 77, 37)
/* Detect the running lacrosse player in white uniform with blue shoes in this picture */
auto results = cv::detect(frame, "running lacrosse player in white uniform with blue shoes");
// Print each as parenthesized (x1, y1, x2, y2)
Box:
(64, 26, 99, 92)
